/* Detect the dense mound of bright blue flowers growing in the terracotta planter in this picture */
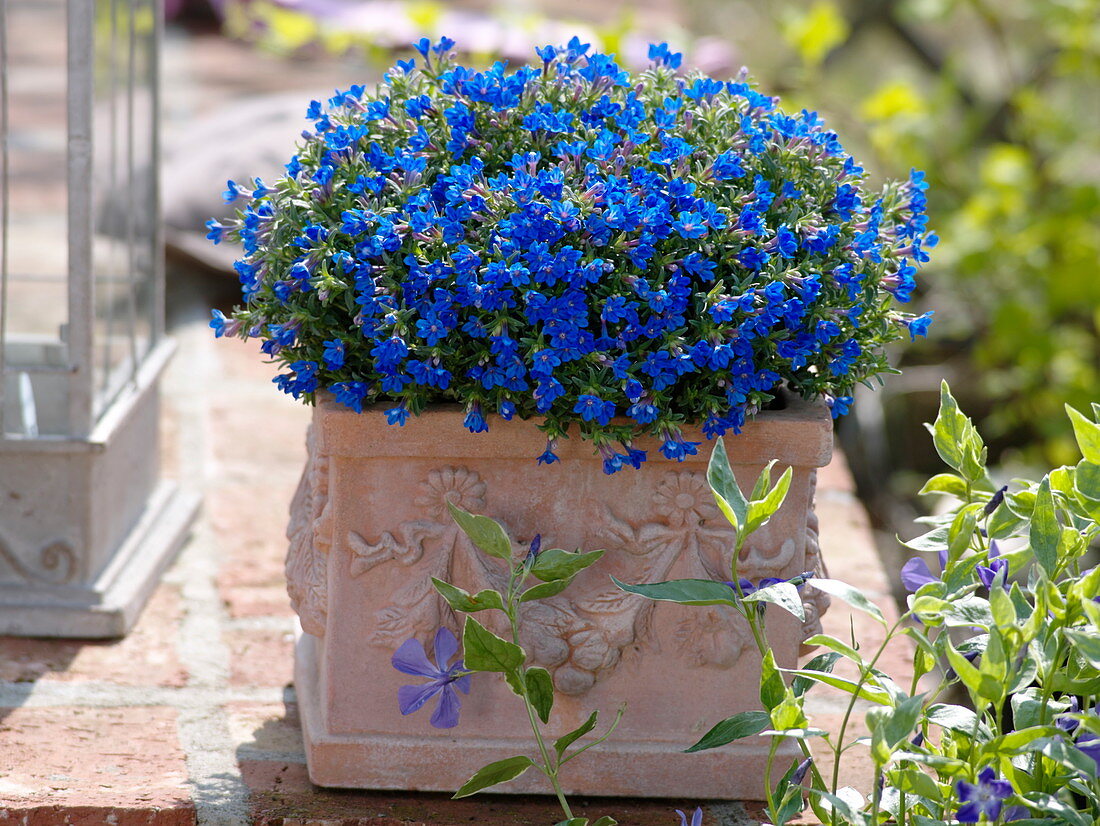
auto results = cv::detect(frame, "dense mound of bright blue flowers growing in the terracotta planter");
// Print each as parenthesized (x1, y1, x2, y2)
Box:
(208, 37, 935, 473)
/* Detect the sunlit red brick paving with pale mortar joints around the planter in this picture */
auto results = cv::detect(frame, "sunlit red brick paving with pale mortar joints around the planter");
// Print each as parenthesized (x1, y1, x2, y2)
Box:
(0, 22, 908, 826)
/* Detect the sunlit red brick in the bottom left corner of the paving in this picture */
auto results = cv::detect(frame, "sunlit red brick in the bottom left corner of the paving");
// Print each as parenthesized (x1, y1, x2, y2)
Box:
(0, 707, 193, 823)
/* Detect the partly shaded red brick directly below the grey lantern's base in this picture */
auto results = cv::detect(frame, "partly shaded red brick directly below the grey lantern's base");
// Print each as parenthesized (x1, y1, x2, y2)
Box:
(0, 585, 187, 687)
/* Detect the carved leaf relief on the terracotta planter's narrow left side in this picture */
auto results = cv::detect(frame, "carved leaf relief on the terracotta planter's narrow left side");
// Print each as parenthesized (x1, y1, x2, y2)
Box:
(286, 426, 332, 637)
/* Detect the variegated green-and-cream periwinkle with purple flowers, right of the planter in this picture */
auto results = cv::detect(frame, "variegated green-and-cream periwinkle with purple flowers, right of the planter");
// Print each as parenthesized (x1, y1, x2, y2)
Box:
(623, 384, 1100, 826)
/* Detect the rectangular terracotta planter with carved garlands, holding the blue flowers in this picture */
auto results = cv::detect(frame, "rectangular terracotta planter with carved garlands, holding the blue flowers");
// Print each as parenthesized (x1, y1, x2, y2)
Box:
(287, 399, 833, 800)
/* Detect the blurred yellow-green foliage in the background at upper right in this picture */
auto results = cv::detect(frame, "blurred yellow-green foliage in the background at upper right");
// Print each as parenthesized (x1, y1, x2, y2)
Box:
(685, 0, 1100, 463)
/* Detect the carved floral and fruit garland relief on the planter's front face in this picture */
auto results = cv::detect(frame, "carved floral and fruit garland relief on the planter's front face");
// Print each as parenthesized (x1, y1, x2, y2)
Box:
(338, 466, 827, 694)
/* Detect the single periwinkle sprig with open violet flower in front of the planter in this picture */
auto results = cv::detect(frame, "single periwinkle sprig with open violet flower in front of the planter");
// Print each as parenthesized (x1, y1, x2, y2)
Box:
(392, 503, 623, 826)
